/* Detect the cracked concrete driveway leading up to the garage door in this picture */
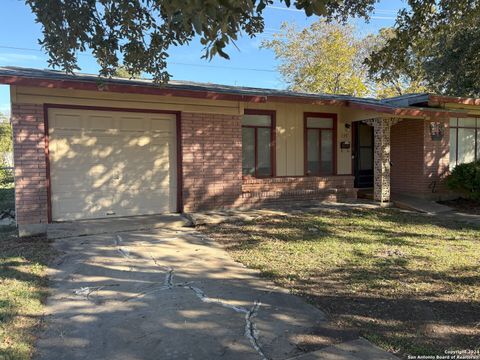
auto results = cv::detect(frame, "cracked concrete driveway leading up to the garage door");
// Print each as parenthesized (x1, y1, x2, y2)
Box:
(36, 217, 398, 360)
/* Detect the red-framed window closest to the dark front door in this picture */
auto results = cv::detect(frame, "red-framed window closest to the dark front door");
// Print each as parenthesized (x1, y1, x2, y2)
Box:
(304, 113, 337, 176)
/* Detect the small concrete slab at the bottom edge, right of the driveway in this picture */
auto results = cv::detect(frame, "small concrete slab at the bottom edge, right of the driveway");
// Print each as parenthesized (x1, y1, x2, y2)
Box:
(288, 338, 398, 360)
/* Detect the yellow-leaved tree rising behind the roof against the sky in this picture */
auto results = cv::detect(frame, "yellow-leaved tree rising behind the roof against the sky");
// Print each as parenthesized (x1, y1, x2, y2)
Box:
(262, 20, 368, 96)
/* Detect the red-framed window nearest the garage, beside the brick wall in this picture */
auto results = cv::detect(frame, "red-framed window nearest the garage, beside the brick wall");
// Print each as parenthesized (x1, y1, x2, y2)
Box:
(242, 110, 275, 177)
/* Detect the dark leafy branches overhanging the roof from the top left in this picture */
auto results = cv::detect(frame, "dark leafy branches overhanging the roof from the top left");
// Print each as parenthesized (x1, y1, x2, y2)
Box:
(25, 0, 378, 82)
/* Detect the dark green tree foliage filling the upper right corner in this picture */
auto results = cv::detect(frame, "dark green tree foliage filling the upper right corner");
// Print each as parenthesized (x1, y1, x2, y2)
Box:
(367, 0, 480, 96)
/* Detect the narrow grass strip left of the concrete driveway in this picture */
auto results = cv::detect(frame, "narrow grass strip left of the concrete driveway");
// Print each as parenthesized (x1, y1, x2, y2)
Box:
(0, 227, 52, 360)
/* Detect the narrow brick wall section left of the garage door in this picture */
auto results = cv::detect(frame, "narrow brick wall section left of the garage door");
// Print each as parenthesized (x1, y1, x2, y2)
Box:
(11, 104, 48, 225)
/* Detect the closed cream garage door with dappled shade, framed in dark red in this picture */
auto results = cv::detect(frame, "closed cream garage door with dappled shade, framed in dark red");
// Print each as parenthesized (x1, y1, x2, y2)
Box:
(48, 109, 177, 221)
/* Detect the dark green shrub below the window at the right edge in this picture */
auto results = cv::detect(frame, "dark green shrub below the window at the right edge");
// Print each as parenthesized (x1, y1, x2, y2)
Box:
(447, 160, 480, 200)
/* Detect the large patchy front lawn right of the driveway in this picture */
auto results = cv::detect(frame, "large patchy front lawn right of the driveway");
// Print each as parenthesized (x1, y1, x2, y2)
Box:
(201, 209, 480, 358)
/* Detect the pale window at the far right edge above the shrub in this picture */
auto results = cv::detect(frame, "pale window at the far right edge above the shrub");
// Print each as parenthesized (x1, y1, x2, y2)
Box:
(450, 117, 480, 169)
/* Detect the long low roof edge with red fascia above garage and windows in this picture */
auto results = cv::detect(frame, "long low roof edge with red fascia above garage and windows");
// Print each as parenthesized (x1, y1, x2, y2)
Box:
(0, 66, 472, 116)
